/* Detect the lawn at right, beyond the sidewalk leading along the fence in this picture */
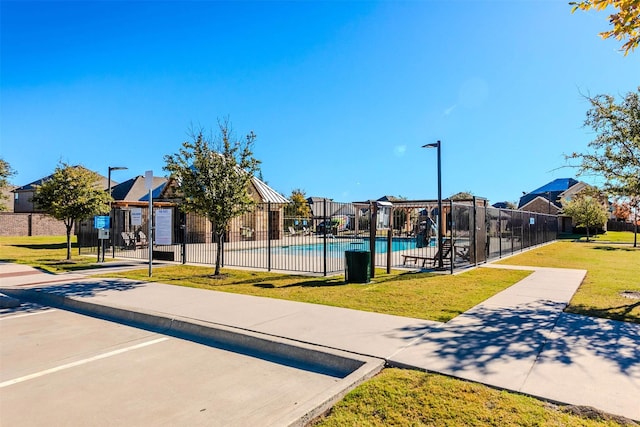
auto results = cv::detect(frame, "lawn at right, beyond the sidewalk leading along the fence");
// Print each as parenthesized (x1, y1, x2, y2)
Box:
(498, 233, 640, 323)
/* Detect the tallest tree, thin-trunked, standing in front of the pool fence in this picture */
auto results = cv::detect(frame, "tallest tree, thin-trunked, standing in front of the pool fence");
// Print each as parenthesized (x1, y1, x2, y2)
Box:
(164, 119, 260, 276)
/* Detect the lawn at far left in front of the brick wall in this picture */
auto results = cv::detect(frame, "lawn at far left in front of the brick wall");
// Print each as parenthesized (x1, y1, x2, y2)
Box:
(0, 236, 108, 273)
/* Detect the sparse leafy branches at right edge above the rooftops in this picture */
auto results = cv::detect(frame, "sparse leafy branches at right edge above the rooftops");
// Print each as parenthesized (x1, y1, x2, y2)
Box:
(566, 87, 640, 197)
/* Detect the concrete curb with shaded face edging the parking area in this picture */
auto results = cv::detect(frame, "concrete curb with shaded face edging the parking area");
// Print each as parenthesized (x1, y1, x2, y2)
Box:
(0, 289, 385, 426)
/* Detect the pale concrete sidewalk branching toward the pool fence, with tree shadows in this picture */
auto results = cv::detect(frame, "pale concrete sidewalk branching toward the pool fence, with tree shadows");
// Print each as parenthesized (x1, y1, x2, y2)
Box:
(0, 264, 640, 420)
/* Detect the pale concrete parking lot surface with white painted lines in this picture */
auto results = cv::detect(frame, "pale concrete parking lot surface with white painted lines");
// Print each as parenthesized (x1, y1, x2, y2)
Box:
(0, 304, 348, 426)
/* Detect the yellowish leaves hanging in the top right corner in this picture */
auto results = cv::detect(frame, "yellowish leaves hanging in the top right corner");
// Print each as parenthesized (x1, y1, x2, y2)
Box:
(569, 0, 640, 56)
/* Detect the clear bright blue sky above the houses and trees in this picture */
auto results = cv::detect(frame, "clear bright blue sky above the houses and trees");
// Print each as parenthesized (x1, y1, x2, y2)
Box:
(0, 0, 640, 203)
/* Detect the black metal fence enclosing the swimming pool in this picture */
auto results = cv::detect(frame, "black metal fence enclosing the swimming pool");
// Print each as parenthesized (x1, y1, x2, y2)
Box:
(78, 199, 558, 275)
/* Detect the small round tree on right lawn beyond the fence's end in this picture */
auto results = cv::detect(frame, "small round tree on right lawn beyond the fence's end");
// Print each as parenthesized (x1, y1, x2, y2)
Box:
(562, 187, 609, 242)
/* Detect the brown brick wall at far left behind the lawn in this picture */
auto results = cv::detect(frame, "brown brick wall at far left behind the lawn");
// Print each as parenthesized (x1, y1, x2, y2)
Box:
(0, 212, 67, 236)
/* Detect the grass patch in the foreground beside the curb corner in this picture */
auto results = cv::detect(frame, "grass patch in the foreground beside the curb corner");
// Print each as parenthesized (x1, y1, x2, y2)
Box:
(312, 369, 636, 427)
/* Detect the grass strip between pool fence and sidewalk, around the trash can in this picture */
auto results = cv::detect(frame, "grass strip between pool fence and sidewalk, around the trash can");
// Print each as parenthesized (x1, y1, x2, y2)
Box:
(100, 265, 530, 322)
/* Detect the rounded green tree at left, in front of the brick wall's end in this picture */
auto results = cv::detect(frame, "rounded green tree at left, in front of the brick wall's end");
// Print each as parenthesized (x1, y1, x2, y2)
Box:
(32, 162, 111, 260)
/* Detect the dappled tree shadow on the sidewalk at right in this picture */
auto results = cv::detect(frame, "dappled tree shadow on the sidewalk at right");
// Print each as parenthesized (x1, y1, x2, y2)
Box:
(392, 301, 640, 373)
